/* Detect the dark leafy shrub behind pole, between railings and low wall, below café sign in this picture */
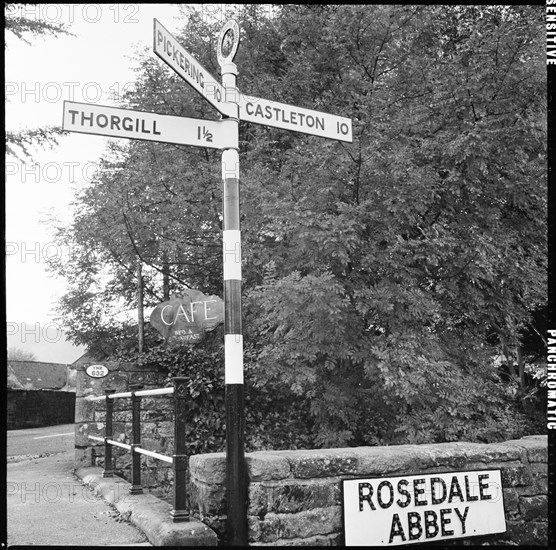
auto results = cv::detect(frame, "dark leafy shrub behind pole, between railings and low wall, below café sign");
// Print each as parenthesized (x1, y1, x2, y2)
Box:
(114, 330, 314, 455)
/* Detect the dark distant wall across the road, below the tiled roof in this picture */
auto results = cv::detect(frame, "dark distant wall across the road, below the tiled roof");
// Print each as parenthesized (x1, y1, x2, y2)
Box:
(6, 388, 75, 430)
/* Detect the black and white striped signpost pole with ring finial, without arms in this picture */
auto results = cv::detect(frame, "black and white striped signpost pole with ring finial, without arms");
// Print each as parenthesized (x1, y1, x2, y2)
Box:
(217, 20, 247, 546)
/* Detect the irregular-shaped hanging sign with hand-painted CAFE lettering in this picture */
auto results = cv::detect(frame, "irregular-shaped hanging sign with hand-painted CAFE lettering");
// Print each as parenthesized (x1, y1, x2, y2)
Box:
(150, 289, 224, 344)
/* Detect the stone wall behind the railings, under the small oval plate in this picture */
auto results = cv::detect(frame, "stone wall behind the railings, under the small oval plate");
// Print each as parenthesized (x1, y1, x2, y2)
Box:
(75, 362, 174, 500)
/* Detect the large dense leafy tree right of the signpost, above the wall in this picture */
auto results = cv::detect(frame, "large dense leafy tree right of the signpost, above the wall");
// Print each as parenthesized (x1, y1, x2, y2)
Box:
(238, 6, 546, 445)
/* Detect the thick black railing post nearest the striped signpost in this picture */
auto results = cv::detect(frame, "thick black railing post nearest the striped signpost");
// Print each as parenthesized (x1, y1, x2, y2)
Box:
(170, 377, 189, 523)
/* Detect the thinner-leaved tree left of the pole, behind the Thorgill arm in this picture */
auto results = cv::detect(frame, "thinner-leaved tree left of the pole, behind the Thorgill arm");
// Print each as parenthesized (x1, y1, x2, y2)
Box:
(49, 63, 226, 355)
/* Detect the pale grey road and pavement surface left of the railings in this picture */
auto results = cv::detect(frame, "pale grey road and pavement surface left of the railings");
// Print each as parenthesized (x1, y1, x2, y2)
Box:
(7, 424, 150, 547)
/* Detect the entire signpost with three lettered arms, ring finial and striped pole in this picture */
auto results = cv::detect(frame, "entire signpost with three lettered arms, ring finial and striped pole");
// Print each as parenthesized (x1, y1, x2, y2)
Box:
(63, 19, 353, 546)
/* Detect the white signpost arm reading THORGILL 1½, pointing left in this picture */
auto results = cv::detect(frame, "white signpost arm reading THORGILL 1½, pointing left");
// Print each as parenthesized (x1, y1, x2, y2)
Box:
(62, 101, 235, 149)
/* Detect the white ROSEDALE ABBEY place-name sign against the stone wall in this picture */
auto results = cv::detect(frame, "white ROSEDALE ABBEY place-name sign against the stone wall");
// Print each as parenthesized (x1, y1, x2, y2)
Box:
(343, 470, 506, 546)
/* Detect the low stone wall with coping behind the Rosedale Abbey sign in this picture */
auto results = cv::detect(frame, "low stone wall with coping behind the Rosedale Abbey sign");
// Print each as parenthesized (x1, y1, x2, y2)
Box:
(189, 436, 548, 546)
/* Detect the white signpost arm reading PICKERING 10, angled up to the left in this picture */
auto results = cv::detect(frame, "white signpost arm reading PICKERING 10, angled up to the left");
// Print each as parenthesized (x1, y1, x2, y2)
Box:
(153, 19, 235, 116)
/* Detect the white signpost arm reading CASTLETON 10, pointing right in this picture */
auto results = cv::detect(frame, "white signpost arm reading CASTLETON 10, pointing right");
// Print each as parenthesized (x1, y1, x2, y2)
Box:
(239, 94, 353, 143)
